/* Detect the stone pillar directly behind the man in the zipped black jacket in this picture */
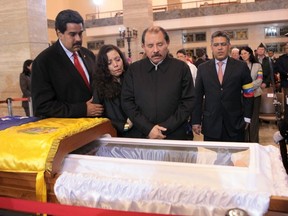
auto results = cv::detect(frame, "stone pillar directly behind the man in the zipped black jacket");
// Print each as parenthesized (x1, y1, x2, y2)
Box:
(123, 0, 153, 61)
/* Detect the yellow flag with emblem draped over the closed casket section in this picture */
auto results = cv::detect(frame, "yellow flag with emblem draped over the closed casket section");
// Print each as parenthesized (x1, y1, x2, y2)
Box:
(0, 118, 108, 202)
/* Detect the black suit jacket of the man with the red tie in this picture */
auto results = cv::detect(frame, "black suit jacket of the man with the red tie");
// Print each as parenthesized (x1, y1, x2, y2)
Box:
(31, 41, 95, 118)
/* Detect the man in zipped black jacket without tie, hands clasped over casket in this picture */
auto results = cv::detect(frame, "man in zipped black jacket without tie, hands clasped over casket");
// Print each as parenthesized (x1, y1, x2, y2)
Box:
(121, 26, 194, 140)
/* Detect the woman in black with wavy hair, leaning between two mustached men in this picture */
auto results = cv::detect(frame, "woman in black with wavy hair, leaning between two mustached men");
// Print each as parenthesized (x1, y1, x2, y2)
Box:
(92, 45, 133, 137)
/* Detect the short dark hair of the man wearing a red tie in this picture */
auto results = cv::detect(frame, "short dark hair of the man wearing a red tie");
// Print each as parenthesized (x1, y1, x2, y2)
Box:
(55, 9, 84, 33)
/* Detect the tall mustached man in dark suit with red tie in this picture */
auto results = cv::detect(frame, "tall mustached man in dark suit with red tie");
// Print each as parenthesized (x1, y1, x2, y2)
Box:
(31, 10, 103, 118)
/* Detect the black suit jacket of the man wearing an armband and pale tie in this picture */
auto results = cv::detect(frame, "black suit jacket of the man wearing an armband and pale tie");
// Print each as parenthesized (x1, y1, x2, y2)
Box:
(192, 57, 254, 139)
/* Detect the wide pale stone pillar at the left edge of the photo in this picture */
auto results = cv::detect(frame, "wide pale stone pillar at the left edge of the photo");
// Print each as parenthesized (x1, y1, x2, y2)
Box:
(0, 0, 48, 116)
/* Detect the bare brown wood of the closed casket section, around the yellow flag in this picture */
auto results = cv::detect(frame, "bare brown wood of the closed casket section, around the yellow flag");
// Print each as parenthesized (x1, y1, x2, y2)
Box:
(0, 121, 116, 203)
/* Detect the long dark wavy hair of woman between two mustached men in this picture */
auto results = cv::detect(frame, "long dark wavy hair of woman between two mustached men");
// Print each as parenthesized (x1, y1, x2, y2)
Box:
(93, 44, 129, 99)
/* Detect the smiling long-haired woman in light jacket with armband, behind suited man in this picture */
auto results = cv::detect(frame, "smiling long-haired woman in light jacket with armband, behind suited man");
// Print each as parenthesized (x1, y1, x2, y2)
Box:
(240, 46, 263, 143)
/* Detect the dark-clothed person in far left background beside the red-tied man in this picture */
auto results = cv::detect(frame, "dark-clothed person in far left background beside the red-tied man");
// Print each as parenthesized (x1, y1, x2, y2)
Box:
(19, 59, 33, 116)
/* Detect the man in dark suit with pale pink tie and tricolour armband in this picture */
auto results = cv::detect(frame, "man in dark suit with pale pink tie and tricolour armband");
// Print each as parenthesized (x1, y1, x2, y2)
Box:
(192, 31, 254, 142)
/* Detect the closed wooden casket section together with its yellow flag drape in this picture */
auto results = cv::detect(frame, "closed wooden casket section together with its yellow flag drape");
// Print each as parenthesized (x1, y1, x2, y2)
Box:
(0, 118, 116, 202)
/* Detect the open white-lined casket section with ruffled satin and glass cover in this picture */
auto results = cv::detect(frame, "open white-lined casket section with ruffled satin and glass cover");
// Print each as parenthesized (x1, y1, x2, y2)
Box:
(54, 138, 288, 216)
